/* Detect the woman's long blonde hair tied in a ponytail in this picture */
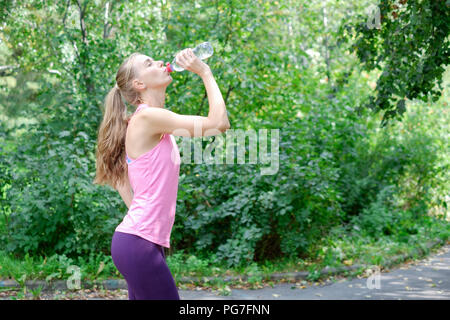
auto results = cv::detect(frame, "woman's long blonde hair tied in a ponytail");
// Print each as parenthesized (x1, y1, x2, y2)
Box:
(93, 52, 142, 189)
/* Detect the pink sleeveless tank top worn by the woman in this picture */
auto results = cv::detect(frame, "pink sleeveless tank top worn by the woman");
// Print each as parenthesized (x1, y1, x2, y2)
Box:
(116, 104, 180, 248)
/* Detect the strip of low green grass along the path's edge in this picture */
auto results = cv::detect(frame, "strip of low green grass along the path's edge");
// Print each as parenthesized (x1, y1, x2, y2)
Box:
(0, 206, 450, 297)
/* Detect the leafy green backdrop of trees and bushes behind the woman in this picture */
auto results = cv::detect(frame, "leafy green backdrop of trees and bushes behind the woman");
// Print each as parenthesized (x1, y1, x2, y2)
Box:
(0, 0, 450, 270)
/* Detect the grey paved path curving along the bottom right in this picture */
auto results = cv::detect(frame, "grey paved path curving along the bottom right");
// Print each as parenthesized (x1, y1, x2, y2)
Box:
(179, 245, 450, 300)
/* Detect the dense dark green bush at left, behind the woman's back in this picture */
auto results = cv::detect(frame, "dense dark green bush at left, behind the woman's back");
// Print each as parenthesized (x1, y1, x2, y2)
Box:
(0, 105, 124, 256)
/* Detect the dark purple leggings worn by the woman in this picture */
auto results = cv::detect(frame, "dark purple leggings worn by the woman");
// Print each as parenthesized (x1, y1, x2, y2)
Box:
(111, 231, 180, 300)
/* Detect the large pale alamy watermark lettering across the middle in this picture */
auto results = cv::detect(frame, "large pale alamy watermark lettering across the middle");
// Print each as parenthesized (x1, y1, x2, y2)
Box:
(171, 125, 280, 175)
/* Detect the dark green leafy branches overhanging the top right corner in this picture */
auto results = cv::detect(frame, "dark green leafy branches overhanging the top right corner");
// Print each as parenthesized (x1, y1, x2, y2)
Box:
(341, 0, 450, 126)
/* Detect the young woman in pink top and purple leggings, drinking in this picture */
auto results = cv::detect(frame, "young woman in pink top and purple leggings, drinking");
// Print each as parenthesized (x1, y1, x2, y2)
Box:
(94, 48, 230, 300)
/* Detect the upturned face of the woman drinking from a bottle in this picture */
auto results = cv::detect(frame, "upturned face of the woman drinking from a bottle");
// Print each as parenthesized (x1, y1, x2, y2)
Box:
(134, 55, 173, 90)
